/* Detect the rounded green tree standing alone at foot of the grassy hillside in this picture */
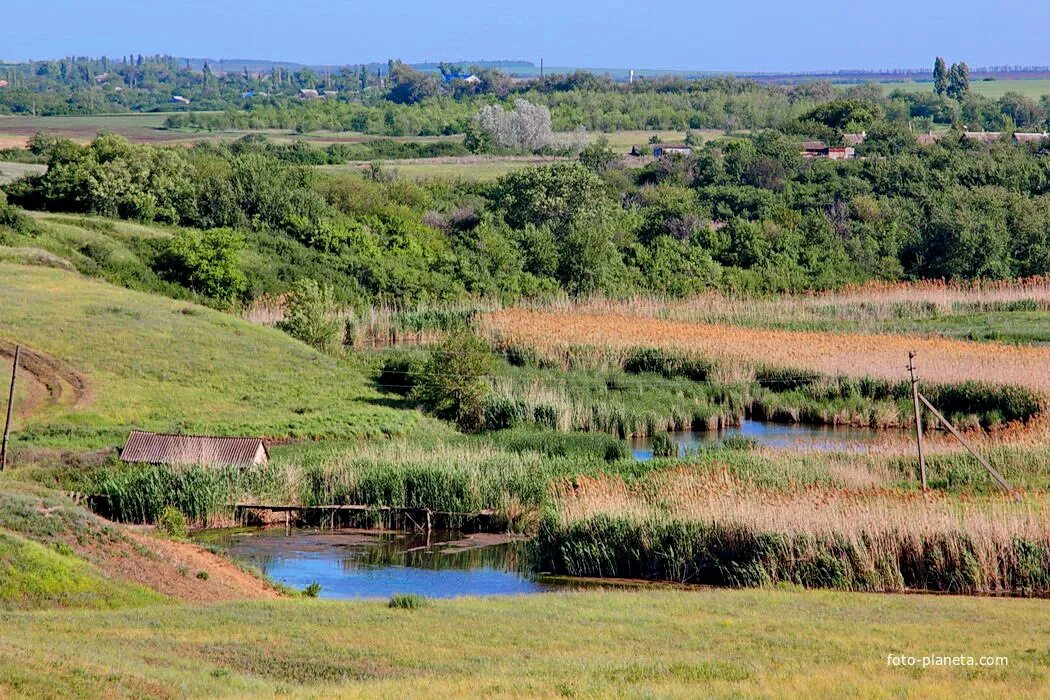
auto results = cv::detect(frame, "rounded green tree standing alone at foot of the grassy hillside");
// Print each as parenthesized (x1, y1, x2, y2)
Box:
(413, 328, 492, 430)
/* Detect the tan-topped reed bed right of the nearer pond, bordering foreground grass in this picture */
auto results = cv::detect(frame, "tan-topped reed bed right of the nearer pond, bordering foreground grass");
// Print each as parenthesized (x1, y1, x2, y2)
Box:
(537, 469, 1050, 595)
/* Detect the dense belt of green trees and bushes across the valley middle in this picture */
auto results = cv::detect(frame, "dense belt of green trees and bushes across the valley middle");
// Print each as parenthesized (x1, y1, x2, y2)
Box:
(0, 108, 1050, 303)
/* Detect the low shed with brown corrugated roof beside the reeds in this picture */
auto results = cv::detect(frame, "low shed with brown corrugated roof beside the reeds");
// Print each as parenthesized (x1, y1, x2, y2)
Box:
(121, 430, 270, 467)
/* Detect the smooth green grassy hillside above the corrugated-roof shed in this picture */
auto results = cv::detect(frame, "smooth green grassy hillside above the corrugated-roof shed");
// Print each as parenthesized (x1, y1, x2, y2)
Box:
(0, 263, 416, 447)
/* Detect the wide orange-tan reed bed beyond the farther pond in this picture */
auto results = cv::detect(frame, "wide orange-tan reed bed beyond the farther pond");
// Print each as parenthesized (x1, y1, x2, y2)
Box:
(481, 310, 1050, 397)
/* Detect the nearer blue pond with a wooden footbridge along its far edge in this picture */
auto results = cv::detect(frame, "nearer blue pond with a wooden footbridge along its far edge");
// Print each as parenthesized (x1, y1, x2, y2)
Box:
(196, 529, 553, 598)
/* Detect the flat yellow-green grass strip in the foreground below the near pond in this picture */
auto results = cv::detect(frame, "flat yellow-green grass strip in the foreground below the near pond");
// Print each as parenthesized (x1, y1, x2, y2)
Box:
(0, 590, 1050, 697)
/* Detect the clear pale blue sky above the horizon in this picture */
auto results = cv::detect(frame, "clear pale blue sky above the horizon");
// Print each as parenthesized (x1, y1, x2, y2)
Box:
(0, 0, 1050, 72)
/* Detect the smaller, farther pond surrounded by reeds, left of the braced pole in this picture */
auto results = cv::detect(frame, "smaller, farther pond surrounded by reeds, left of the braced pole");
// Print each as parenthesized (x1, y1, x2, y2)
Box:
(631, 420, 879, 460)
